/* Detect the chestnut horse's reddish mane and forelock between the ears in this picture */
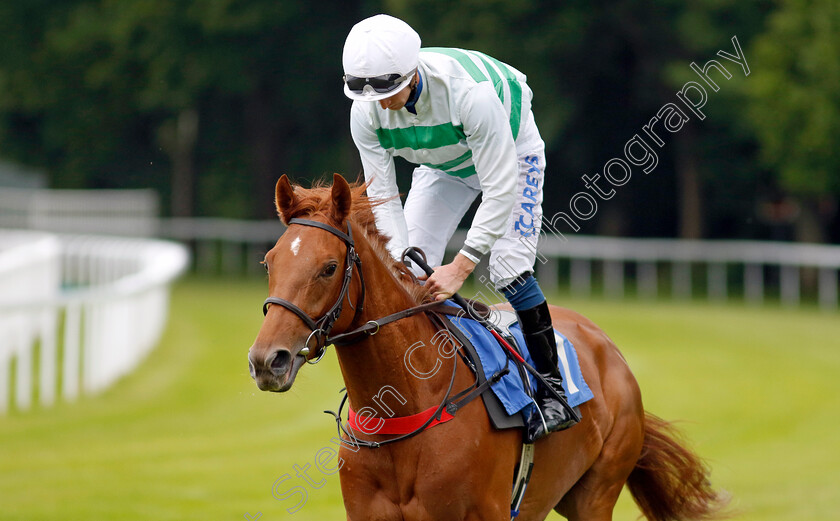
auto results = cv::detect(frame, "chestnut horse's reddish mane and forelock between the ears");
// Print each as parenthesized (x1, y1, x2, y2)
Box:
(288, 180, 428, 304)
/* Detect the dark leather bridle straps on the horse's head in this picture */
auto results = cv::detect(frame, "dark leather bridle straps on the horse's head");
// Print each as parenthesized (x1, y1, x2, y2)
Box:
(263, 219, 365, 364)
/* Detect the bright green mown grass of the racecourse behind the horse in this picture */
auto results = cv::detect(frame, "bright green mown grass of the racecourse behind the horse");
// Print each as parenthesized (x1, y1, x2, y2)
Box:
(0, 279, 840, 521)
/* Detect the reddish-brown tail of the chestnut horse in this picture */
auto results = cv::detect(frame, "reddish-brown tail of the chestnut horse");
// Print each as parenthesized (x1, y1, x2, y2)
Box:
(627, 413, 729, 521)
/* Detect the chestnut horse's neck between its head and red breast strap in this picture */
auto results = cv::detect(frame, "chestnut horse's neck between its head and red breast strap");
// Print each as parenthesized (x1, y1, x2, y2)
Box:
(337, 238, 455, 417)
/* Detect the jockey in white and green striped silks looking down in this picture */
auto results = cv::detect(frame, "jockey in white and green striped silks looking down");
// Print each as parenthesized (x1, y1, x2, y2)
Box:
(342, 14, 576, 439)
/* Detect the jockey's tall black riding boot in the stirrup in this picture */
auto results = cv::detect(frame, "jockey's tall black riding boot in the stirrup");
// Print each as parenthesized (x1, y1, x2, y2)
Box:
(516, 301, 580, 440)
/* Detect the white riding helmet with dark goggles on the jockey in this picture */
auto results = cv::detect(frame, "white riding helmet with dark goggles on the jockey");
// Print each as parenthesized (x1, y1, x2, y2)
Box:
(342, 14, 420, 101)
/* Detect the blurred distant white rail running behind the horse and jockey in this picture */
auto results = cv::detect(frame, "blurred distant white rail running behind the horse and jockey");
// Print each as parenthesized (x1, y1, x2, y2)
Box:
(160, 218, 840, 311)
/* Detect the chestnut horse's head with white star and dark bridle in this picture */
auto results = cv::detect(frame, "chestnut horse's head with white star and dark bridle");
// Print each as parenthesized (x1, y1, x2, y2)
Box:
(248, 174, 362, 392)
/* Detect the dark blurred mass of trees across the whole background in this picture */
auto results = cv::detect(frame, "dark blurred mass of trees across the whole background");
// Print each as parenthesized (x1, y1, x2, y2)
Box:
(0, 0, 828, 248)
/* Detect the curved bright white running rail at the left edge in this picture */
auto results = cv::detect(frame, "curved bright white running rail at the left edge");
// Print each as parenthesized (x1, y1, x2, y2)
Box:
(0, 230, 188, 414)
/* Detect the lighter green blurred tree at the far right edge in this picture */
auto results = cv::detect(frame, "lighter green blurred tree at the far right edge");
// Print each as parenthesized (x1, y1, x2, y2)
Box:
(748, 0, 840, 242)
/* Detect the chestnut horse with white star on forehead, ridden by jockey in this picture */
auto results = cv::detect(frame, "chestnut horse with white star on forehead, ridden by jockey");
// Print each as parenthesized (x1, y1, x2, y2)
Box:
(248, 175, 723, 521)
